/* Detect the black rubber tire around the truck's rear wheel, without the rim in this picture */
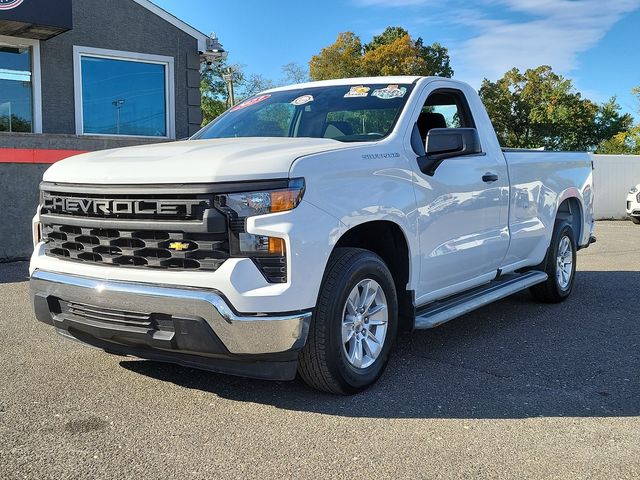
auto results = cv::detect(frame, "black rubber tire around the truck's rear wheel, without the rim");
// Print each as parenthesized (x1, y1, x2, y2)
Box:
(530, 220, 578, 303)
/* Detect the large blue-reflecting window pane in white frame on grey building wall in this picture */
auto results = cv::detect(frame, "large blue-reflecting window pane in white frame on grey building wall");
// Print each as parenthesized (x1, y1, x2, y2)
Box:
(81, 55, 167, 137)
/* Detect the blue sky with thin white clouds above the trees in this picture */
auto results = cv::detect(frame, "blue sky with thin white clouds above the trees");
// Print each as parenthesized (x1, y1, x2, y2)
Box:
(153, 0, 640, 119)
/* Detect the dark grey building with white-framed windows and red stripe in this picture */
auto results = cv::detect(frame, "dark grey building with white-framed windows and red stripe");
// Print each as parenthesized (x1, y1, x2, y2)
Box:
(0, 0, 207, 260)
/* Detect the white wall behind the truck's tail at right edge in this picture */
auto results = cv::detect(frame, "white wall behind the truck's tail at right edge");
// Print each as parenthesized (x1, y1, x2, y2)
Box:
(593, 155, 640, 220)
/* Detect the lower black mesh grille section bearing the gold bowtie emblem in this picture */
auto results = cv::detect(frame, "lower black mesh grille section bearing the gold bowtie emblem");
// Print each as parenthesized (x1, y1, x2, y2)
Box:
(42, 224, 229, 270)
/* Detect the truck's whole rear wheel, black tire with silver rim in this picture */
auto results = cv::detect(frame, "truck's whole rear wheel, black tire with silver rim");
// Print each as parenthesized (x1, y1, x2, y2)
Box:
(531, 221, 577, 303)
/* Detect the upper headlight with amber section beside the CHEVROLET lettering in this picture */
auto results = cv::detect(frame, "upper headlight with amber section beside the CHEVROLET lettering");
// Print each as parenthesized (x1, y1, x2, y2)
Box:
(218, 178, 304, 218)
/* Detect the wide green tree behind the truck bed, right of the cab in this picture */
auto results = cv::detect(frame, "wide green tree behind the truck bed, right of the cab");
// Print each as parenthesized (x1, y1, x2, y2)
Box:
(479, 65, 632, 150)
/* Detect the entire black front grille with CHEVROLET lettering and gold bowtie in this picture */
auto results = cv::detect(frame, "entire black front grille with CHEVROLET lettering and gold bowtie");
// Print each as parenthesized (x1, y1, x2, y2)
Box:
(40, 183, 230, 271)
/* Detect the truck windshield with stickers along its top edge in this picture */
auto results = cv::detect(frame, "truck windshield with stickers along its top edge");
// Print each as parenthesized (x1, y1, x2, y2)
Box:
(193, 84, 413, 142)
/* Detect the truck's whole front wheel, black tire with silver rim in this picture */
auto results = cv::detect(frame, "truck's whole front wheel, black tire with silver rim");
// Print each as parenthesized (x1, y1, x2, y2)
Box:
(298, 248, 398, 395)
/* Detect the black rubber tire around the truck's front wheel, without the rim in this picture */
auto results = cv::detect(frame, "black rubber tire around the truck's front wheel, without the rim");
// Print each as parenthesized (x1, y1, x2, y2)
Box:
(298, 248, 398, 395)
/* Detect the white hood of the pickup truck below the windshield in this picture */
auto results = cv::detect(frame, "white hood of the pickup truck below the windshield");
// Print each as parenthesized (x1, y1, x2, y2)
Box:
(44, 138, 353, 185)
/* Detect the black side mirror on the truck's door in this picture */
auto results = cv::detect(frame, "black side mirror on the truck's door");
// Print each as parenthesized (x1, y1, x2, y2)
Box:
(418, 128, 482, 176)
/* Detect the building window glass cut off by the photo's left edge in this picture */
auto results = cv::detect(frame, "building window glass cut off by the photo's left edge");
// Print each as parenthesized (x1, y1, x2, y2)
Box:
(0, 45, 33, 132)
